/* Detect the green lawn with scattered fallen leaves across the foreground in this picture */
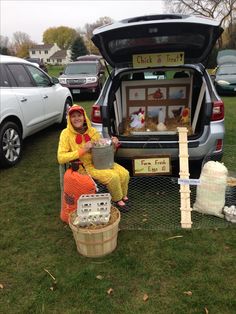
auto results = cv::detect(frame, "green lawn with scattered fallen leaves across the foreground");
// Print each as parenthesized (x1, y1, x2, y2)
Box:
(0, 97, 236, 314)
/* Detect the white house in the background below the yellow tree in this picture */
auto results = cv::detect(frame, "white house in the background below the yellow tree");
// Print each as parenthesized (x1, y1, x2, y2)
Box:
(29, 43, 71, 65)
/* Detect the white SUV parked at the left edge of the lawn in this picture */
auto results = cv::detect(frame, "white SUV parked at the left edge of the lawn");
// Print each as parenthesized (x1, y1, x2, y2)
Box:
(0, 55, 72, 167)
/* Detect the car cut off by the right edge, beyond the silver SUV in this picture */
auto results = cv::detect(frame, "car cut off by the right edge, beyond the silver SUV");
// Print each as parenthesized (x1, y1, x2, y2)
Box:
(214, 49, 236, 96)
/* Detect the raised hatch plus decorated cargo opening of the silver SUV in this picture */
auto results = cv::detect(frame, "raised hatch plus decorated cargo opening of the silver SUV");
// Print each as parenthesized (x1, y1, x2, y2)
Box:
(92, 15, 223, 141)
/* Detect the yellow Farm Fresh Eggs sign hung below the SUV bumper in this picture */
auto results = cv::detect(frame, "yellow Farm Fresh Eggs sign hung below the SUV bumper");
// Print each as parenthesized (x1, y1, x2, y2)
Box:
(133, 155, 171, 176)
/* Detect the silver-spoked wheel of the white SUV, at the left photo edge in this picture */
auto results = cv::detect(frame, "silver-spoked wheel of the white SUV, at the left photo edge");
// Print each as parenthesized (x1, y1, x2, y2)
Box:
(0, 121, 22, 167)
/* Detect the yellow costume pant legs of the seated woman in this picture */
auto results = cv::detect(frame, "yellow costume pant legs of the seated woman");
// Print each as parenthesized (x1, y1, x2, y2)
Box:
(87, 163, 129, 202)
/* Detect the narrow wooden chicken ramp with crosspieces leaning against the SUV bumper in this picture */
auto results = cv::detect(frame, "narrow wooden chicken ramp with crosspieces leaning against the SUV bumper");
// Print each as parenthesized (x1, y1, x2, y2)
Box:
(177, 127, 192, 228)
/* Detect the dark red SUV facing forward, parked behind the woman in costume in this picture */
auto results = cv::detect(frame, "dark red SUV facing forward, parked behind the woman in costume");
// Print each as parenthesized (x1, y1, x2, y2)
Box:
(59, 56, 105, 97)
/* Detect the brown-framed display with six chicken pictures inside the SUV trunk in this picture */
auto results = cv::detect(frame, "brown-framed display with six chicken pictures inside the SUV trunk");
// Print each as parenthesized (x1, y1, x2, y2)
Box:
(119, 78, 192, 134)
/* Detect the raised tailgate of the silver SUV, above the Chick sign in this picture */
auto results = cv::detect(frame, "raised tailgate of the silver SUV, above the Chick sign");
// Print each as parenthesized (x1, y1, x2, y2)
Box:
(92, 14, 223, 68)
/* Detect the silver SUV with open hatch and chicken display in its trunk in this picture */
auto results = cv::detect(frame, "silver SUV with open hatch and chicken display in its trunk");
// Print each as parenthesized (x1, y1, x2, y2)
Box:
(91, 14, 225, 175)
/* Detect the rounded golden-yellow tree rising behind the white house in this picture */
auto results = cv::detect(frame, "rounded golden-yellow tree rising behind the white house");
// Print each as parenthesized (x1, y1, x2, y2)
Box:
(43, 26, 78, 50)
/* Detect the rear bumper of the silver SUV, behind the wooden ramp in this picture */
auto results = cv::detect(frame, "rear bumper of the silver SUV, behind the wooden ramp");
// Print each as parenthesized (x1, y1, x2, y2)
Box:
(115, 122, 224, 176)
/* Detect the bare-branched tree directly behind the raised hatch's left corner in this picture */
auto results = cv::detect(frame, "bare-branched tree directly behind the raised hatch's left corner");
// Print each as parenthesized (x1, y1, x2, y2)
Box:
(83, 16, 113, 54)
